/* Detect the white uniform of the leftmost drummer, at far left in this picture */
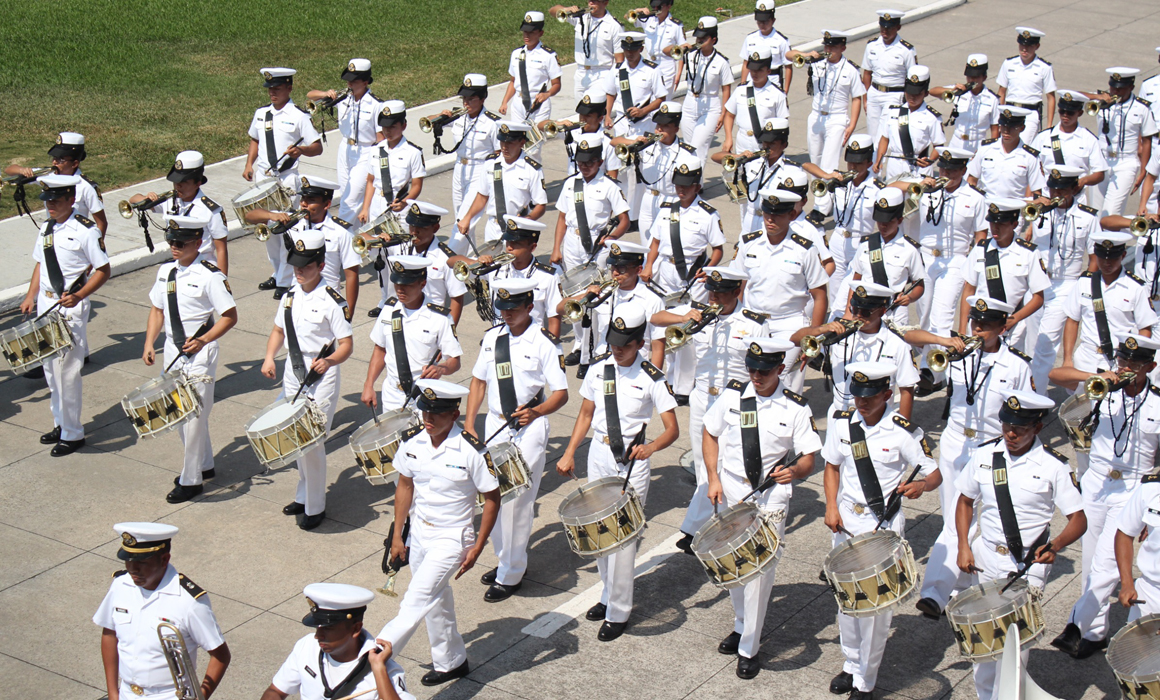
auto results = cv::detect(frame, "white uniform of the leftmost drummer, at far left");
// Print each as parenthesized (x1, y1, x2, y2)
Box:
(32, 210, 109, 440)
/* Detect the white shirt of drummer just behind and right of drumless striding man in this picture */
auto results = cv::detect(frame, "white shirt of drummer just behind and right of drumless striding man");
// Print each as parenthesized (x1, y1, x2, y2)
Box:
(471, 325, 568, 420)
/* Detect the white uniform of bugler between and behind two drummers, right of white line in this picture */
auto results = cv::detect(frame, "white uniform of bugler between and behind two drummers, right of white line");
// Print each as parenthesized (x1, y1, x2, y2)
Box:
(672, 303, 771, 535)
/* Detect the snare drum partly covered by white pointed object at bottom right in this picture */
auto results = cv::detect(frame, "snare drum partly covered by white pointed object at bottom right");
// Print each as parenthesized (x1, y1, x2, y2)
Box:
(947, 577, 1048, 663)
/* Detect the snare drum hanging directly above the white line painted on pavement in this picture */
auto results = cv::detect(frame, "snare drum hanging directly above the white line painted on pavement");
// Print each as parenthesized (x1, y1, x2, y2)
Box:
(559, 476, 645, 557)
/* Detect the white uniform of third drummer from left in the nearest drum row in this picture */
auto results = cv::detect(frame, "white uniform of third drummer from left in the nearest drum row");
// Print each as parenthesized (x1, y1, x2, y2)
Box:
(274, 281, 353, 515)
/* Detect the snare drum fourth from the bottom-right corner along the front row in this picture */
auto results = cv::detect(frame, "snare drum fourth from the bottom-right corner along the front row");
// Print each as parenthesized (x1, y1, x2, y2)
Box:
(691, 501, 781, 589)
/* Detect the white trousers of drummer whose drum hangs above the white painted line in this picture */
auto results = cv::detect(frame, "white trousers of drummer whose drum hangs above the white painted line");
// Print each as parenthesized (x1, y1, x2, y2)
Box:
(588, 435, 650, 622)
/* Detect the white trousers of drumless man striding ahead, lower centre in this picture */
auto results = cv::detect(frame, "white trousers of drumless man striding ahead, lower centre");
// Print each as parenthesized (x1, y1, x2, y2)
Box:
(377, 518, 476, 672)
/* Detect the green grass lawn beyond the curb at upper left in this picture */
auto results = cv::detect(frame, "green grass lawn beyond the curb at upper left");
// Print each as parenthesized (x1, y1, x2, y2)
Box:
(0, 0, 788, 216)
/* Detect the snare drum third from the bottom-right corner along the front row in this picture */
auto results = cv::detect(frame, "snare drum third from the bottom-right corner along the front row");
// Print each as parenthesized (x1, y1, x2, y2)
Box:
(824, 531, 920, 618)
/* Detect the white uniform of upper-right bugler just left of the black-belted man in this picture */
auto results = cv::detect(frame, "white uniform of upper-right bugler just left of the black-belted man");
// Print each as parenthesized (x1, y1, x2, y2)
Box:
(805, 56, 867, 173)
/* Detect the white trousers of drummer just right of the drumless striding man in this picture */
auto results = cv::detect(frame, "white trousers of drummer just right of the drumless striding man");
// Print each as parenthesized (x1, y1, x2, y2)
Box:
(484, 413, 549, 586)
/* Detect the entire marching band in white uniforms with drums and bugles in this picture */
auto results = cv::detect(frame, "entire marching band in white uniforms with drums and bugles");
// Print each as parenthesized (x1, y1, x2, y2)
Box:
(11, 0, 1160, 700)
